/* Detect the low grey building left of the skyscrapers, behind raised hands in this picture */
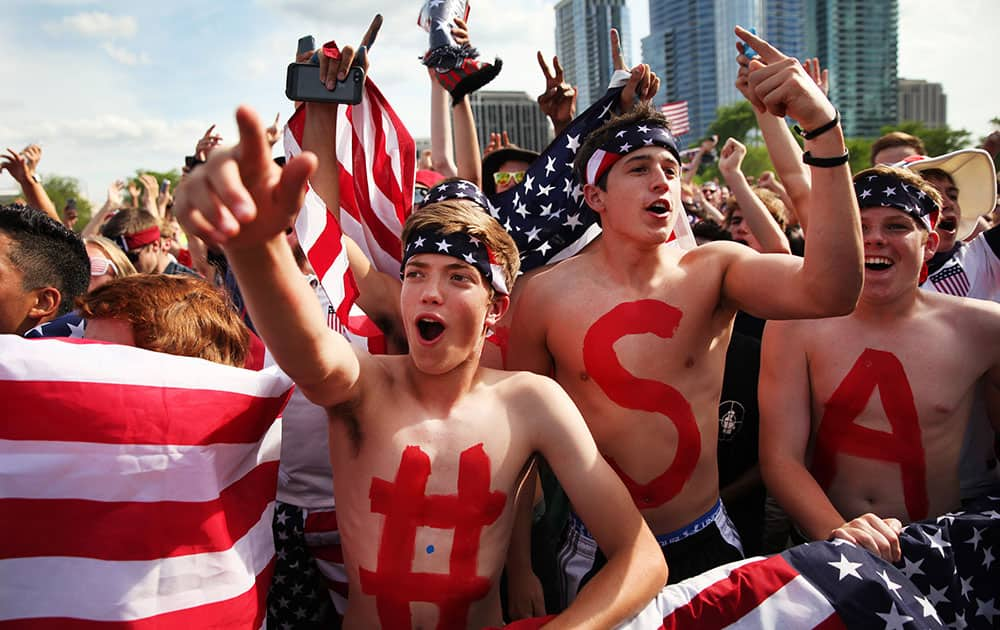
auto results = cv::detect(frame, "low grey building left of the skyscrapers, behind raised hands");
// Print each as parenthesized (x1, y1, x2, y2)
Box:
(469, 90, 552, 152)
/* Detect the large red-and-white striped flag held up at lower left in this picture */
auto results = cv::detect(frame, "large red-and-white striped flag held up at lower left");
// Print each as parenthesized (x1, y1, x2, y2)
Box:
(0, 335, 291, 629)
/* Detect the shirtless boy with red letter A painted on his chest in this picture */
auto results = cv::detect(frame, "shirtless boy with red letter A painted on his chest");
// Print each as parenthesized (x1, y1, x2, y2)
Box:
(759, 166, 1000, 560)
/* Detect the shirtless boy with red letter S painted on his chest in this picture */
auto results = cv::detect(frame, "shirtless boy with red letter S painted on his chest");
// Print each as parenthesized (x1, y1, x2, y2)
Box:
(510, 29, 862, 599)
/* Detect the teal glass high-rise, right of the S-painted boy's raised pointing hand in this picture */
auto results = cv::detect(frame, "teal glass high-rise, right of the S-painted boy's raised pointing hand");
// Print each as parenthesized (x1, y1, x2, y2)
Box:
(806, 0, 899, 137)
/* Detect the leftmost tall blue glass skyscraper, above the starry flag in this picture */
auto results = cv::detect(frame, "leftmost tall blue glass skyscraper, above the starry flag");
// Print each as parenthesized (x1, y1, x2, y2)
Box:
(555, 0, 632, 112)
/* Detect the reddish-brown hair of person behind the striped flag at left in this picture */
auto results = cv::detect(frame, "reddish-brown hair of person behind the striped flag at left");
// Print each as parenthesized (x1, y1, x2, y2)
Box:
(76, 273, 250, 367)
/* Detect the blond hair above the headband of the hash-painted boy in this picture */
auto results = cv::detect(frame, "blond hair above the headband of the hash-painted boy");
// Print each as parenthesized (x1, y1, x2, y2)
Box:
(402, 199, 521, 296)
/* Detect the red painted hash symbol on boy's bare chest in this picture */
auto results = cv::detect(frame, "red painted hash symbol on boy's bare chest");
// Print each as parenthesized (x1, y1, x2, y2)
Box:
(360, 444, 507, 629)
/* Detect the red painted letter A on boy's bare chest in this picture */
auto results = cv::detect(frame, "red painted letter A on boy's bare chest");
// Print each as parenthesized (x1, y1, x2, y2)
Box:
(812, 348, 928, 521)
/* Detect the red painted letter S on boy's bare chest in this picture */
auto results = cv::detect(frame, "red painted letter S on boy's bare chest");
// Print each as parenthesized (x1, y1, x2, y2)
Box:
(583, 300, 701, 509)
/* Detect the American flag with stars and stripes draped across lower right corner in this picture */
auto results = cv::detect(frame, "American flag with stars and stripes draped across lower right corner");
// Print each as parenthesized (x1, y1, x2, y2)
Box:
(508, 494, 1000, 630)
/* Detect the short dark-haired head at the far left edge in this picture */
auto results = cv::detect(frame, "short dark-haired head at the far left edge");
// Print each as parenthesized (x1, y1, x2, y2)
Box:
(0, 205, 90, 335)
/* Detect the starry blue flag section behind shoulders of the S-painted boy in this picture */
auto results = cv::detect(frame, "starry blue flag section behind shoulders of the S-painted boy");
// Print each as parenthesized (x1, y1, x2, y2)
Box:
(490, 81, 696, 271)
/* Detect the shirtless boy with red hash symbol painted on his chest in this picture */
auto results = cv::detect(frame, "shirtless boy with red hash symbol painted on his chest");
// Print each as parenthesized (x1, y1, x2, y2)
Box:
(175, 108, 666, 628)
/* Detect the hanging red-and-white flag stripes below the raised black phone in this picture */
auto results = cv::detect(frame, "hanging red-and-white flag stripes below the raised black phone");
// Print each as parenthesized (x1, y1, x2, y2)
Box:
(284, 78, 416, 351)
